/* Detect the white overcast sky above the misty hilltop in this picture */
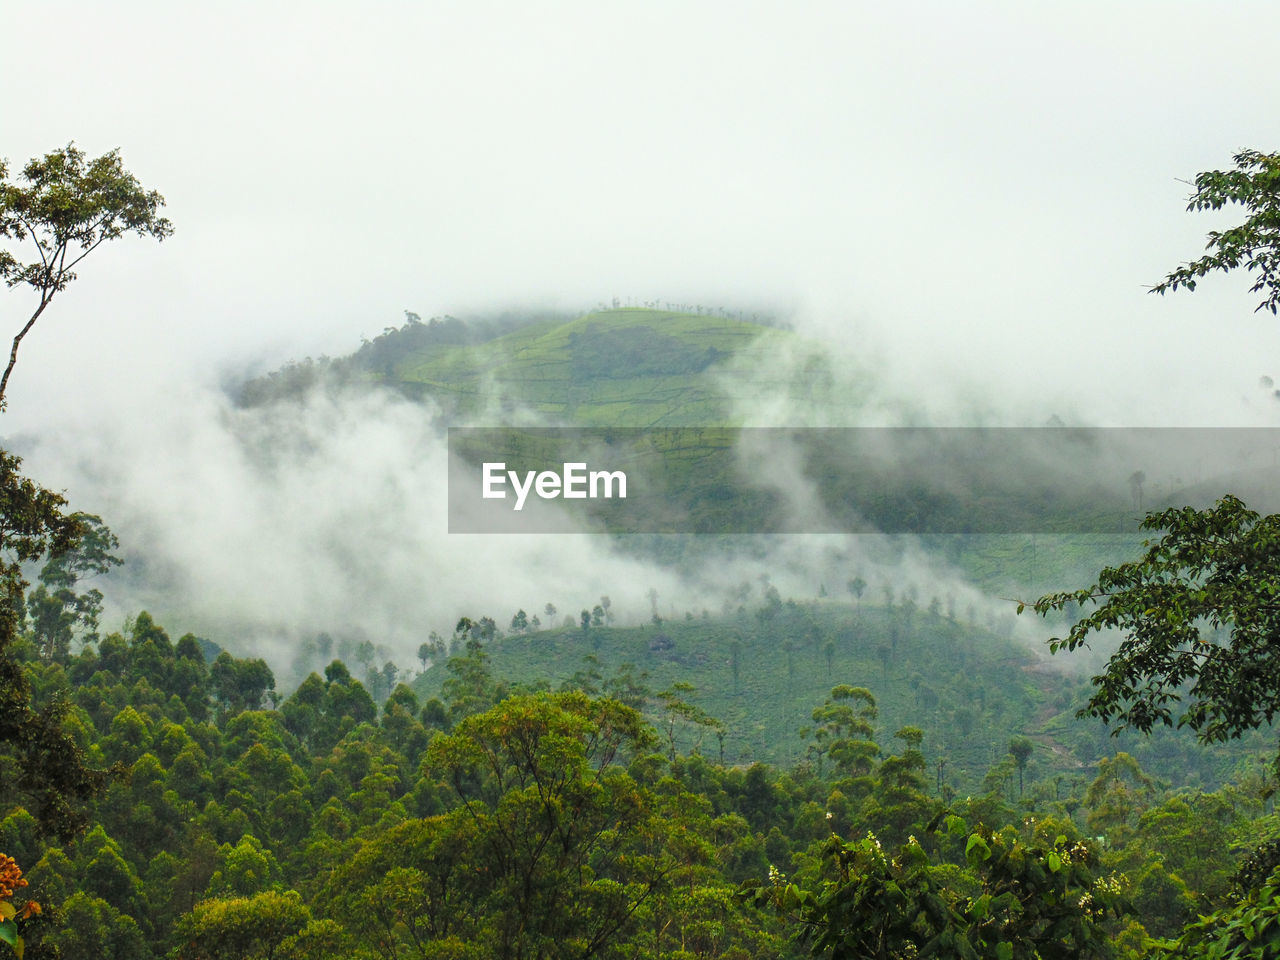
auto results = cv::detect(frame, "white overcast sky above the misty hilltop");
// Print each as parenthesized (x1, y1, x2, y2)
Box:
(0, 0, 1280, 431)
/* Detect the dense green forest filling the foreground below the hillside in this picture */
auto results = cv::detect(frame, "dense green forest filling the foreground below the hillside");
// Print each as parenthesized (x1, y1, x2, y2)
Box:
(0, 555, 1275, 957)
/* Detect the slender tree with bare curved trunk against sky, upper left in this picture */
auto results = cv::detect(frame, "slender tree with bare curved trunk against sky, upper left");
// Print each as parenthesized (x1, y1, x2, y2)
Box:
(0, 143, 173, 410)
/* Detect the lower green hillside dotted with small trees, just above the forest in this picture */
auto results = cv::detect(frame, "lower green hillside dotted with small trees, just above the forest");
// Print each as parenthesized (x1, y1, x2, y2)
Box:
(413, 600, 1270, 795)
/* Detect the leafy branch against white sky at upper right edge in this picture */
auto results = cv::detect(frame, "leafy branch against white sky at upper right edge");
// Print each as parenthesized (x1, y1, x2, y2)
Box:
(1151, 150, 1280, 314)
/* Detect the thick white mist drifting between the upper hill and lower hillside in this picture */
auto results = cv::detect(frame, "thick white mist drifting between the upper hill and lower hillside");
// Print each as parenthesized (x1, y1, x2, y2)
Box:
(5, 330, 1111, 668)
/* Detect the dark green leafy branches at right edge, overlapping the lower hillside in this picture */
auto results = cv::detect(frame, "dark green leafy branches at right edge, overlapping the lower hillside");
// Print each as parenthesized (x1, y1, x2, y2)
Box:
(1036, 495, 1280, 741)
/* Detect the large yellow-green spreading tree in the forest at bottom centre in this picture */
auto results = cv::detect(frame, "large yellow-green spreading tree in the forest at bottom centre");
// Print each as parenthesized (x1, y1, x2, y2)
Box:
(419, 692, 678, 960)
